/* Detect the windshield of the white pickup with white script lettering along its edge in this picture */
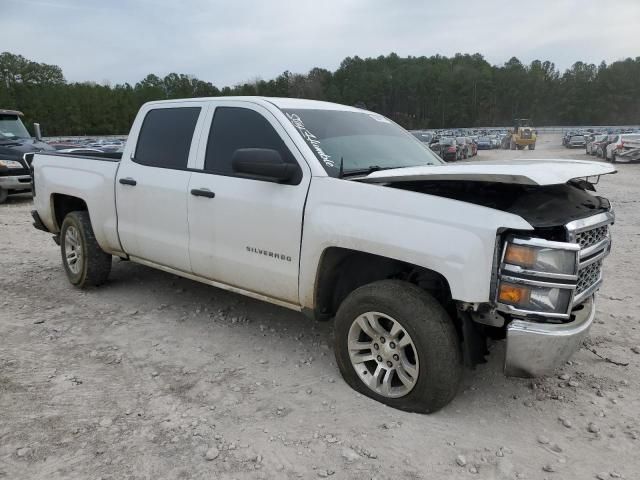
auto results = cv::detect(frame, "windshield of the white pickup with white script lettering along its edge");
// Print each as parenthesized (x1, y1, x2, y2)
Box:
(282, 109, 442, 177)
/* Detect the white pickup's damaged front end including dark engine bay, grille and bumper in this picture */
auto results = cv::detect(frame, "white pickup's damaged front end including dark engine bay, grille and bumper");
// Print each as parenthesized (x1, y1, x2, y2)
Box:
(378, 167, 615, 377)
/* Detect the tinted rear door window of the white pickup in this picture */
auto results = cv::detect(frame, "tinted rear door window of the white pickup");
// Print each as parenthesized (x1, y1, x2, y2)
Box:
(134, 107, 200, 169)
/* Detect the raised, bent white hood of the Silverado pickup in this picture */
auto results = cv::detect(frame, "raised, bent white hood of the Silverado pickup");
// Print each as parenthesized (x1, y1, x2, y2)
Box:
(359, 159, 616, 186)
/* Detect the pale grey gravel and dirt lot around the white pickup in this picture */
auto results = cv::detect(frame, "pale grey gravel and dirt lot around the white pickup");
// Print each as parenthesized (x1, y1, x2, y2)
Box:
(0, 132, 640, 480)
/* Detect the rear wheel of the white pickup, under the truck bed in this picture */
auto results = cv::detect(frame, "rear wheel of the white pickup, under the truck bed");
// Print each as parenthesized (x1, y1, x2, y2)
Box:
(60, 211, 111, 288)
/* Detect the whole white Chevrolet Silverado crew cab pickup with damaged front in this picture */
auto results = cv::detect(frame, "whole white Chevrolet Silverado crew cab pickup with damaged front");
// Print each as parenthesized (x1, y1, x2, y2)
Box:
(32, 97, 615, 412)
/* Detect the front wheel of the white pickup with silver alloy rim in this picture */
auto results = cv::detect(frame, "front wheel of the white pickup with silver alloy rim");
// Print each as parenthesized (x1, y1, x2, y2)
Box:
(335, 280, 462, 413)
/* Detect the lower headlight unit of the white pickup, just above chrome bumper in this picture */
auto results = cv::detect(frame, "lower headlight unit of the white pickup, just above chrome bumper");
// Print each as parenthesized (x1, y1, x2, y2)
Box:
(498, 282, 572, 313)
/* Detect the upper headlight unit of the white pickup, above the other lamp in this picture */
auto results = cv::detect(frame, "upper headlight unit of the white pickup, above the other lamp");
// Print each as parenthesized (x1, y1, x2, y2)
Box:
(503, 238, 579, 275)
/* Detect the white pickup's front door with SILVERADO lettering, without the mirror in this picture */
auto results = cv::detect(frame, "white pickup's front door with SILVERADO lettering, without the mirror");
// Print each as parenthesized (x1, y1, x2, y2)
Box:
(188, 101, 311, 304)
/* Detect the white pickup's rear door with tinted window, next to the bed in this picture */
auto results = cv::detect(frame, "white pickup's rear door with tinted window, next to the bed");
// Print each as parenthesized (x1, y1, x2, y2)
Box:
(115, 102, 204, 272)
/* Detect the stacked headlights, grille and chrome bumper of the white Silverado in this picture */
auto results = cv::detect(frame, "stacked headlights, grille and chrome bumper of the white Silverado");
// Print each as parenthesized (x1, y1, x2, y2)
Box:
(495, 211, 614, 376)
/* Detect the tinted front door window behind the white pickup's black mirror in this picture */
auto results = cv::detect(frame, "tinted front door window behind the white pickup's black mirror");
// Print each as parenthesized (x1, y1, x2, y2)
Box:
(204, 107, 297, 176)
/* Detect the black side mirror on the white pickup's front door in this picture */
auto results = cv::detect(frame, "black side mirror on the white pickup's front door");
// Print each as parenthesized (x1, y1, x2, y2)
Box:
(231, 148, 300, 183)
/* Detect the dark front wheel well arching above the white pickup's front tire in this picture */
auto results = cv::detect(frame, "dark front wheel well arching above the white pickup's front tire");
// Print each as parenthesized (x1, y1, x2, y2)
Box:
(314, 247, 455, 319)
